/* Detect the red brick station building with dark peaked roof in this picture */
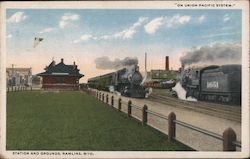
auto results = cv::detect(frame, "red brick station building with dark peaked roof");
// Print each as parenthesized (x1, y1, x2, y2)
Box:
(37, 59, 84, 90)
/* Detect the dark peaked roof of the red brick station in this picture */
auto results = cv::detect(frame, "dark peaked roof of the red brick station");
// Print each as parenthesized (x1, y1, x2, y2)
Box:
(37, 59, 84, 78)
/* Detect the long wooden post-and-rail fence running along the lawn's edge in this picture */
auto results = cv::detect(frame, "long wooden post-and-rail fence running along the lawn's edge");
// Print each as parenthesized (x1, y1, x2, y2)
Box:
(93, 91, 241, 151)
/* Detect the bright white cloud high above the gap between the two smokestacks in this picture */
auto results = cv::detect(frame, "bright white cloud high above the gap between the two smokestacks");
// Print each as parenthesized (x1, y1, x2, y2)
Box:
(144, 17, 163, 34)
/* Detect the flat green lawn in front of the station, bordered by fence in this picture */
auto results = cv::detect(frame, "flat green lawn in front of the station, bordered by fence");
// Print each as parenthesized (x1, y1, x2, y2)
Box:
(7, 91, 189, 151)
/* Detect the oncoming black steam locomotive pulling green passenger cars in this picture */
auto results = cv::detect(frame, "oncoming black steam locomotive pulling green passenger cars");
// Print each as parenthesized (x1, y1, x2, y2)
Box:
(88, 65, 146, 98)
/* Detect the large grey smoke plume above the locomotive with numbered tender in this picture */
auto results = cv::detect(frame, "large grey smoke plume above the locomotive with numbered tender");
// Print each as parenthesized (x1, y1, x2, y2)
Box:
(180, 43, 241, 66)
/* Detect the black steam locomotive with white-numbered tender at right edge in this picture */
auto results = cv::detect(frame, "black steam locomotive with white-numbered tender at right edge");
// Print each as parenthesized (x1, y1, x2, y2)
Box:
(181, 65, 241, 104)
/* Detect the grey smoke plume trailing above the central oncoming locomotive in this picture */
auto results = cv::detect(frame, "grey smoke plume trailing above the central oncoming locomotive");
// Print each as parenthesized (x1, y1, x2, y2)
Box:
(95, 56, 138, 69)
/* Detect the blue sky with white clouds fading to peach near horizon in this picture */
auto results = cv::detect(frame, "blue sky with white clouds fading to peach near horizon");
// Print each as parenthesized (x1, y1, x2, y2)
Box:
(6, 9, 242, 82)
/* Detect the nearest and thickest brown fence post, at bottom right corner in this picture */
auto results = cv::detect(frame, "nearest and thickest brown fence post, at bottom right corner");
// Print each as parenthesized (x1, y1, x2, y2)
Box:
(223, 127, 236, 151)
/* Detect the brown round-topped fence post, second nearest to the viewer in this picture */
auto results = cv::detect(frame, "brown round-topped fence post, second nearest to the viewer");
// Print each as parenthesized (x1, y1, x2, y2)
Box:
(168, 112, 176, 141)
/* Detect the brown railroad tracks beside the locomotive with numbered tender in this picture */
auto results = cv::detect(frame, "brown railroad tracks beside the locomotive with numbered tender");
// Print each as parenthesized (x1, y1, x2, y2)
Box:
(148, 93, 241, 122)
